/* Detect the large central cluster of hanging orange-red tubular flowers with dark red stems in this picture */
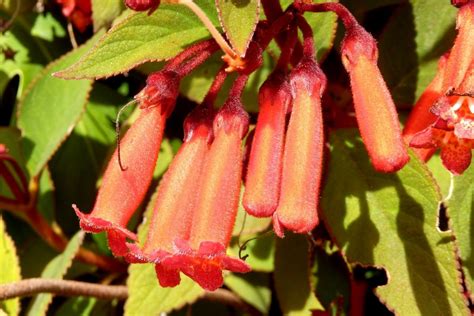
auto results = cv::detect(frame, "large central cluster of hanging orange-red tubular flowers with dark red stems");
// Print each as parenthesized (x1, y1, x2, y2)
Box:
(73, 1, 408, 290)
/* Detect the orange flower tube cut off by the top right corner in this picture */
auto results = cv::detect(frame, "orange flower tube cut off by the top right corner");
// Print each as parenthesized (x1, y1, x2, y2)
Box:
(443, 1, 474, 92)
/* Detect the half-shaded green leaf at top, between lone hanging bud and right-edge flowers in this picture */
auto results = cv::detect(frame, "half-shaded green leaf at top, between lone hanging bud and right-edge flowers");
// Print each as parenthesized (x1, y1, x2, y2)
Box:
(379, 0, 456, 105)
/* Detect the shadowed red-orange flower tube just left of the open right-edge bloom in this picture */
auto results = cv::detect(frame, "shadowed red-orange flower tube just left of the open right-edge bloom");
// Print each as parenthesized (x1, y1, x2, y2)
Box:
(403, 55, 447, 161)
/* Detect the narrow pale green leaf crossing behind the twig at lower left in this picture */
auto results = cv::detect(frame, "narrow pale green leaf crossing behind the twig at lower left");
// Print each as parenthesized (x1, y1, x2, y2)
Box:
(27, 231, 84, 316)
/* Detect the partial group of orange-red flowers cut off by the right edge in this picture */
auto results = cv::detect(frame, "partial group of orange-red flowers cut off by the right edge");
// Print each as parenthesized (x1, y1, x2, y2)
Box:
(403, 0, 474, 174)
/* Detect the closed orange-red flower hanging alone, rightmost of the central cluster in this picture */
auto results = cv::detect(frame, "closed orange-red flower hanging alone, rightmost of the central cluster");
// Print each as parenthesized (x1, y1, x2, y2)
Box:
(341, 25, 409, 172)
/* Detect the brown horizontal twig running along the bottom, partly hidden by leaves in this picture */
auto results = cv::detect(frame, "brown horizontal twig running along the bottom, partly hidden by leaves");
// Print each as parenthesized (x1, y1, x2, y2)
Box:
(0, 278, 261, 315)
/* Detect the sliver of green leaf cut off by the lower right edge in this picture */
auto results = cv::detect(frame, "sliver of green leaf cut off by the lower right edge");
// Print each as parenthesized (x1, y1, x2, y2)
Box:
(447, 163, 474, 294)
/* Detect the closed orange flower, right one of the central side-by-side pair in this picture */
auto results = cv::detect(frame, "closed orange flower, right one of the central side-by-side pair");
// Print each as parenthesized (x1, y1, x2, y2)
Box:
(273, 58, 326, 237)
